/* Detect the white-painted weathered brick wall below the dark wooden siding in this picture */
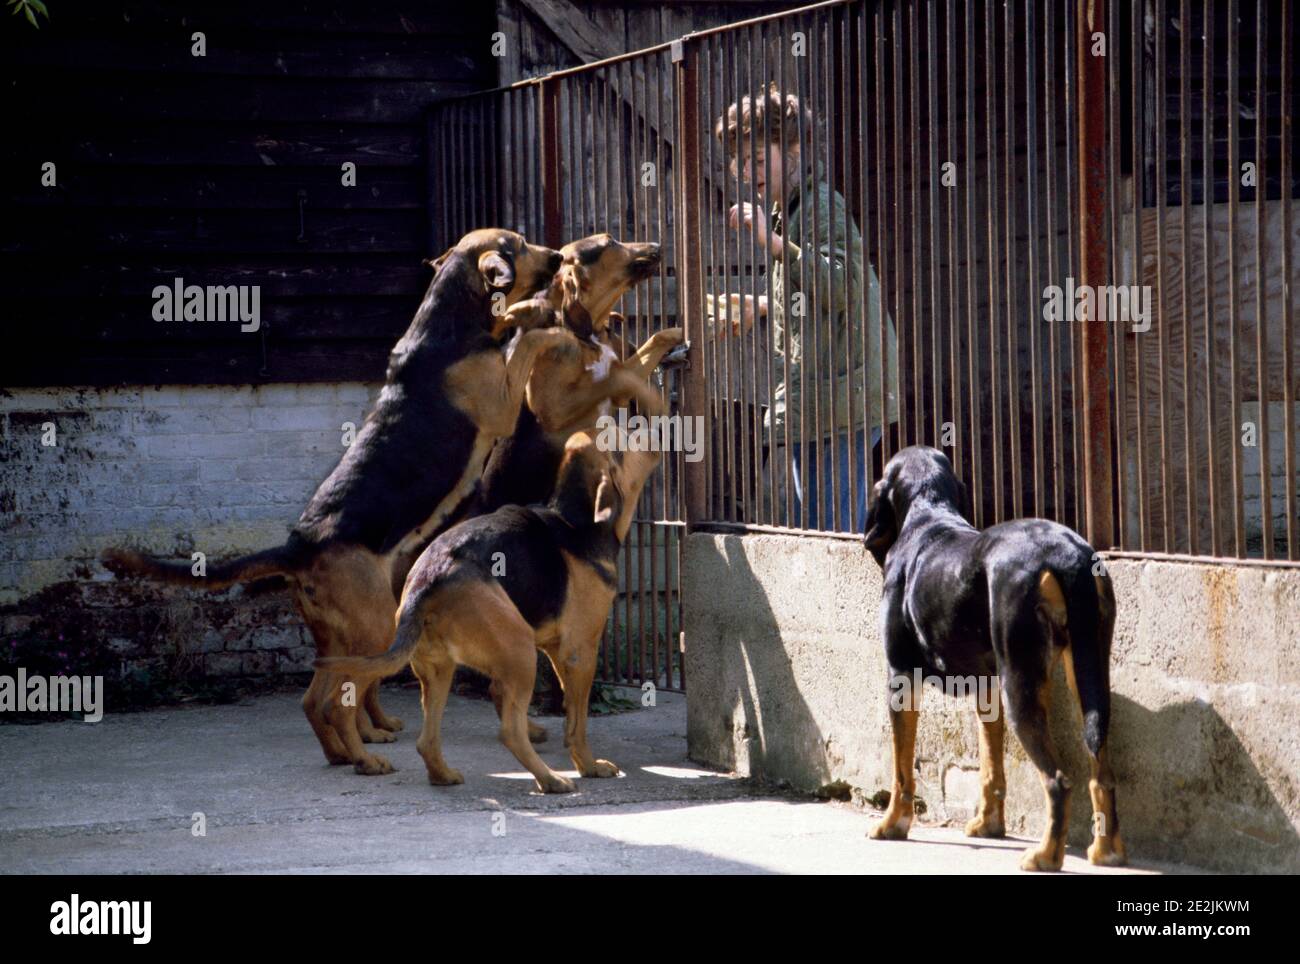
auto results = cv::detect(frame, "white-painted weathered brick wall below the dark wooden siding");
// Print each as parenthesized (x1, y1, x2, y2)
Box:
(0, 382, 377, 676)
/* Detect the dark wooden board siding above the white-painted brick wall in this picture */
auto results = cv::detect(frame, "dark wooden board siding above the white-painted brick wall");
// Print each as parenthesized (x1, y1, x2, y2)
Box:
(0, 0, 497, 386)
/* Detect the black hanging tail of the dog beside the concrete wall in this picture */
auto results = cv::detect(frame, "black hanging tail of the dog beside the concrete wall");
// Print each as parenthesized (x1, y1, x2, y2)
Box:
(1066, 561, 1115, 756)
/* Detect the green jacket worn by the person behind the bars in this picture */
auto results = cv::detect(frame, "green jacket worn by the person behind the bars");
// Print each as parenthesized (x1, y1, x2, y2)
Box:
(767, 175, 898, 444)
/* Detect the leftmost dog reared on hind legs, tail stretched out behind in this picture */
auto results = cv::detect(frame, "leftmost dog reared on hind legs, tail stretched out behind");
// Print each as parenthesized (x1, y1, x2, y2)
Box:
(105, 229, 567, 773)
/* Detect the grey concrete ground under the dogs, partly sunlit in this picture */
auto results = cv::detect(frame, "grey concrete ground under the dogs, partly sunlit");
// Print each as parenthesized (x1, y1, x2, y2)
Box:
(0, 689, 1184, 874)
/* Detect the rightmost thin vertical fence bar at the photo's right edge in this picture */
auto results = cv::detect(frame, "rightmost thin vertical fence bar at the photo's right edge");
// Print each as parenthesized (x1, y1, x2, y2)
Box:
(1278, 4, 1300, 559)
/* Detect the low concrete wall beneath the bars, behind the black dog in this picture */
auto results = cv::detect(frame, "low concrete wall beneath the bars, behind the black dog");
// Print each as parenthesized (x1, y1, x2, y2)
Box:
(683, 533, 1300, 873)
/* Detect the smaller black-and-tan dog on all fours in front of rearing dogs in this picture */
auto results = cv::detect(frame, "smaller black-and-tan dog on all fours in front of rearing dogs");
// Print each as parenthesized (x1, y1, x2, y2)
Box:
(317, 413, 659, 793)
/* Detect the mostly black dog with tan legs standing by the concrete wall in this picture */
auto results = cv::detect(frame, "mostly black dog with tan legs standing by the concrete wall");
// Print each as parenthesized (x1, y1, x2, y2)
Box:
(865, 446, 1125, 870)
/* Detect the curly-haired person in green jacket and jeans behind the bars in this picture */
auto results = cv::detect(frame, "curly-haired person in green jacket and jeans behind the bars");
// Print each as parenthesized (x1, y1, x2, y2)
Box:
(715, 84, 898, 531)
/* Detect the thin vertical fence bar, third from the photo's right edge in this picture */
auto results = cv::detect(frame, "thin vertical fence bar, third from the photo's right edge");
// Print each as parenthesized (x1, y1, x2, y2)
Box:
(1227, 0, 1245, 557)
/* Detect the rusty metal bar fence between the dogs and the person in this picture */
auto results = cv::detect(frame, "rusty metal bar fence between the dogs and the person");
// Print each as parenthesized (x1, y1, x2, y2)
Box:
(429, 0, 1300, 687)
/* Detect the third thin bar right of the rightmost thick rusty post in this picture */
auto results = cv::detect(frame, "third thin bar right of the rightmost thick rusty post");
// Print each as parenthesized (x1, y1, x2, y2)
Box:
(1178, 0, 1200, 556)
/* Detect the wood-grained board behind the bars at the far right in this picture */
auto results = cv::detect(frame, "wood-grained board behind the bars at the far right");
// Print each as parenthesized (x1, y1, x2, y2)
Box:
(1117, 200, 1300, 555)
